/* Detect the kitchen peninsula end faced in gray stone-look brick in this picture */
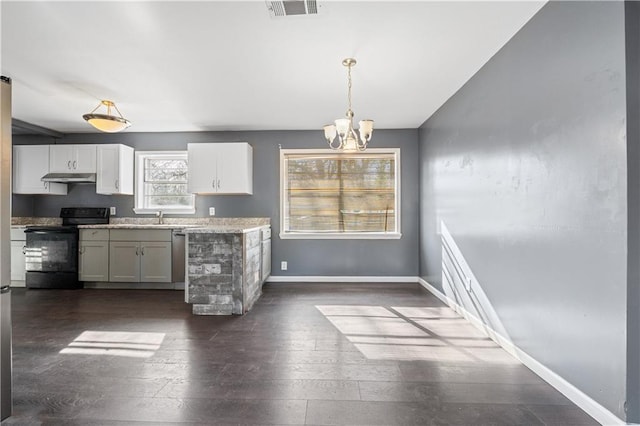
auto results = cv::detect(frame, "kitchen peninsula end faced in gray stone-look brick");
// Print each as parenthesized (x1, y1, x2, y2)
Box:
(184, 224, 271, 315)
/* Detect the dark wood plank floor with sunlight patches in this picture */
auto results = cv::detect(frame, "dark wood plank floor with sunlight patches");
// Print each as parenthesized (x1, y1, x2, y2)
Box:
(2, 284, 597, 426)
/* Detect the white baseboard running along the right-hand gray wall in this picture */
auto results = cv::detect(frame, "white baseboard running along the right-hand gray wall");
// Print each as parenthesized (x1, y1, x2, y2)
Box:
(418, 278, 627, 426)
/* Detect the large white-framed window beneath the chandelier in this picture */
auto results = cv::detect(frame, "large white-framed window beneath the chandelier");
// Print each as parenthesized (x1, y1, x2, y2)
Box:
(280, 149, 401, 238)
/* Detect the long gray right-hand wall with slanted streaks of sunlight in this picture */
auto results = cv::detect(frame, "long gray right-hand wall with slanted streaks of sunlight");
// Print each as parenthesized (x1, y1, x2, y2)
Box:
(419, 2, 637, 419)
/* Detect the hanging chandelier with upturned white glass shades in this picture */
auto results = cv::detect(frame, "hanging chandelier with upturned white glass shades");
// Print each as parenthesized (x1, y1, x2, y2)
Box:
(323, 58, 373, 151)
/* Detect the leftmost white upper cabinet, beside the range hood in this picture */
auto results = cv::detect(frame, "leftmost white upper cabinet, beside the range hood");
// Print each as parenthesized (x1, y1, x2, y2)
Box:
(13, 145, 67, 195)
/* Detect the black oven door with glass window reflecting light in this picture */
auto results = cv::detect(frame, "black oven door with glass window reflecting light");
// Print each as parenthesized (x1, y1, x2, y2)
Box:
(25, 226, 78, 274)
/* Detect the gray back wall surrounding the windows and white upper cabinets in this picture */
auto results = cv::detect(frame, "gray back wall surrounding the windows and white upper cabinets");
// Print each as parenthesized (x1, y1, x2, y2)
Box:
(13, 129, 419, 277)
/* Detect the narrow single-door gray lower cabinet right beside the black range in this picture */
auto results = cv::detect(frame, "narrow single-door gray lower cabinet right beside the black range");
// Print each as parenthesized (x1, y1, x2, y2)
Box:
(78, 229, 109, 281)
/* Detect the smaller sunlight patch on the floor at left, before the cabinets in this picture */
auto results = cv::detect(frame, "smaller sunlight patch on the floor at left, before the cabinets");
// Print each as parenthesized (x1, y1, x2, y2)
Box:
(60, 330, 165, 358)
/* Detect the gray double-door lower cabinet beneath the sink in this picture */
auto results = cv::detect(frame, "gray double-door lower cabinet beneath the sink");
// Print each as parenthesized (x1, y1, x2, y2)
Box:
(109, 229, 171, 283)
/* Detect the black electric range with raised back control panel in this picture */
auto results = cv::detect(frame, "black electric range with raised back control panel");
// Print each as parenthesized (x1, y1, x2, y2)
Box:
(25, 207, 109, 289)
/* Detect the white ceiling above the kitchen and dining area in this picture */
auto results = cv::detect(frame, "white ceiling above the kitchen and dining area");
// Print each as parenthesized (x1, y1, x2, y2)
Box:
(0, 0, 544, 133)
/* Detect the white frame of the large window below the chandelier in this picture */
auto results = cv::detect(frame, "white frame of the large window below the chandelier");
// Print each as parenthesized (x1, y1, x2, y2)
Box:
(279, 148, 402, 240)
